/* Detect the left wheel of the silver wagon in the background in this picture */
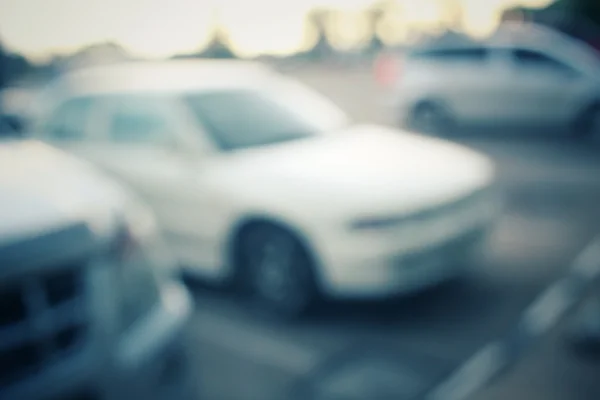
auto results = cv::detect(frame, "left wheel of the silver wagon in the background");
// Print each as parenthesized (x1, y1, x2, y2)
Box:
(408, 102, 455, 136)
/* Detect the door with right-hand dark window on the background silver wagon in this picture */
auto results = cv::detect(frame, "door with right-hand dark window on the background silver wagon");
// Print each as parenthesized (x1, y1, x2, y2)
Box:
(505, 48, 586, 125)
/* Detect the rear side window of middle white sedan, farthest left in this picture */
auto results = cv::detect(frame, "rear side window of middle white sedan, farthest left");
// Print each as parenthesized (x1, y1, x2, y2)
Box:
(42, 98, 95, 141)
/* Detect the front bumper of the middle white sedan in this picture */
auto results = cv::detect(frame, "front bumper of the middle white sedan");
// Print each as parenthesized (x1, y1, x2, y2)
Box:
(322, 226, 489, 298)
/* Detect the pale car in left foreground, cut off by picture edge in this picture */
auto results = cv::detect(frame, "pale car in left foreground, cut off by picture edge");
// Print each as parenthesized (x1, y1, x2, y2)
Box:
(0, 140, 192, 400)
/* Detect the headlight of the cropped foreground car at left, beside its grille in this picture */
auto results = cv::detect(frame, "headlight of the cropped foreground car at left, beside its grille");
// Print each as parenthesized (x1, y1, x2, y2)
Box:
(112, 202, 173, 330)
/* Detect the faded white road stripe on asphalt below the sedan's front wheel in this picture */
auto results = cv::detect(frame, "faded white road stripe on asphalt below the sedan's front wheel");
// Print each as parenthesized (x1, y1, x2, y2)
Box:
(192, 313, 320, 375)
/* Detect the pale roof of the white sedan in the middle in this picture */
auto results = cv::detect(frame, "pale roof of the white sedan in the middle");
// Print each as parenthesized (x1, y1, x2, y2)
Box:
(51, 60, 274, 96)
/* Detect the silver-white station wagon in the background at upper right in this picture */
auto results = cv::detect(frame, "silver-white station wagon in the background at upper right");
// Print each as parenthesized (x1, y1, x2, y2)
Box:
(391, 23, 600, 140)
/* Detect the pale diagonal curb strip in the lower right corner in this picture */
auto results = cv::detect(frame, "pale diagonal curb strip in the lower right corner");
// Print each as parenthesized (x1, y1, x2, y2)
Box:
(424, 237, 600, 400)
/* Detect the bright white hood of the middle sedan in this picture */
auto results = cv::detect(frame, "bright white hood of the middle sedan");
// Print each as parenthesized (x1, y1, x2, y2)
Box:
(221, 126, 494, 217)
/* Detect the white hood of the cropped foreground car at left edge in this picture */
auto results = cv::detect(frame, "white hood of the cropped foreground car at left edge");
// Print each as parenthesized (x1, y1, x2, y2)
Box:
(0, 141, 124, 247)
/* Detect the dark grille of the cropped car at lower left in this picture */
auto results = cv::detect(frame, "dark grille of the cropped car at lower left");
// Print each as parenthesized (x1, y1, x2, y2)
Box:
(0, 262, 86, 390)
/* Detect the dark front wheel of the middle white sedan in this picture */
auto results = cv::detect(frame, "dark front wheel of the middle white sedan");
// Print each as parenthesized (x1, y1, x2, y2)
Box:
(238, 223, 317, 319)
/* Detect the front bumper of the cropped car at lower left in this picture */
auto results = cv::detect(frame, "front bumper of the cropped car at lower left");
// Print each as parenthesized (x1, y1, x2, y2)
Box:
(0, 283, 193, 400)
